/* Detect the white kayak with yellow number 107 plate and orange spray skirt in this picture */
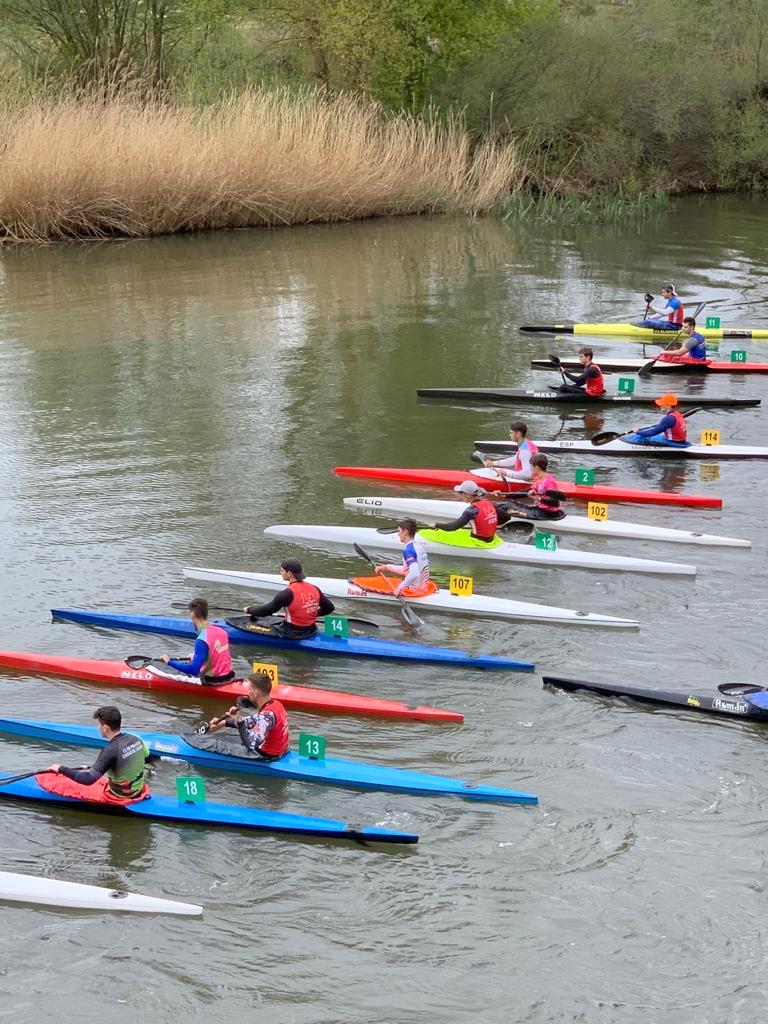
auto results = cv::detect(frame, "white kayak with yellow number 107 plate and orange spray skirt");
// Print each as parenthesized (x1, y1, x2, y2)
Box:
(183, 566, 640, 626)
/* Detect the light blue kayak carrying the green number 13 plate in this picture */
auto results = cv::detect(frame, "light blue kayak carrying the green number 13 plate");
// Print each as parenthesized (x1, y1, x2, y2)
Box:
(0, 718, 539, 806)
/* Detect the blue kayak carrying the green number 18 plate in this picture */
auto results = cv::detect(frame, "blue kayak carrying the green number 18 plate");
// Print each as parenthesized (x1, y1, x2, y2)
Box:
(0, 770, 419, 843)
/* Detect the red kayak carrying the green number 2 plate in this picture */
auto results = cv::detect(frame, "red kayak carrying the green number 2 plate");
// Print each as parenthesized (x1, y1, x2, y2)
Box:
(334, 466, 723, 509)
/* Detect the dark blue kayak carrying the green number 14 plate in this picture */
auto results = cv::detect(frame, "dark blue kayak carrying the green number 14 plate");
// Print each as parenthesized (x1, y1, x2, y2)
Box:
(51, 608, 536, 672)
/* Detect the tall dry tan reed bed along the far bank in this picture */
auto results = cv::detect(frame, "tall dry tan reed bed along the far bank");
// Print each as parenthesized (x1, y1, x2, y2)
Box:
(0, 91, 524, 242)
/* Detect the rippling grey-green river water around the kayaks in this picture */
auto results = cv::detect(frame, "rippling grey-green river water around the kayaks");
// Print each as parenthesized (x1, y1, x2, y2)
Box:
(0, 198, 768, 1024)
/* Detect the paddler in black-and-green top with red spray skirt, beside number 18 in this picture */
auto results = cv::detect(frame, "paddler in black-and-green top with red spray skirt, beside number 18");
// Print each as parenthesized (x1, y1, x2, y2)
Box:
(44, 705, 150, 804)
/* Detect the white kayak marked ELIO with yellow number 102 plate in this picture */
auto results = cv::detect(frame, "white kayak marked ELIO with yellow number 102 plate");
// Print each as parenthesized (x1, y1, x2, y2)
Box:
(344, 495, 752, 548)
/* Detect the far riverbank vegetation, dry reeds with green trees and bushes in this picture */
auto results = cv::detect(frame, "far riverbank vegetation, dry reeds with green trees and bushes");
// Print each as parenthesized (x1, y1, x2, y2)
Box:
(0, 0, 768, 239)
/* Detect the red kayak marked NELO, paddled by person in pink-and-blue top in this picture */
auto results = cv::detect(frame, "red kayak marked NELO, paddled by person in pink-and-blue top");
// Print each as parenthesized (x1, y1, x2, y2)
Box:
(0, 650, 464, 722)
